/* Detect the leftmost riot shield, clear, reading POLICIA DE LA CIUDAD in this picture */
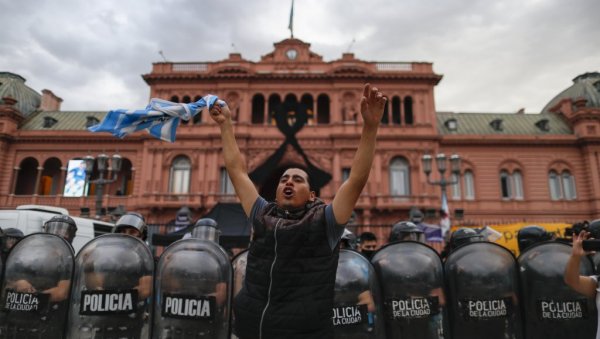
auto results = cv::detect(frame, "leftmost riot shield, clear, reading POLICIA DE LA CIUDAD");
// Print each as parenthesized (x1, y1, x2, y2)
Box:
(0, 233, 75, 339)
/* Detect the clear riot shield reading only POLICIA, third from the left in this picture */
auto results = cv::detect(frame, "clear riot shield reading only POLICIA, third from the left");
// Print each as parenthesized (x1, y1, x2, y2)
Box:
(152, 238, 233, 339)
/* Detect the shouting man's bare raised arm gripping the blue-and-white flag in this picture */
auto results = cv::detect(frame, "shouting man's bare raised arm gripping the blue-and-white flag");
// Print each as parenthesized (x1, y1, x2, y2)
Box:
(210, 104, 258, 216)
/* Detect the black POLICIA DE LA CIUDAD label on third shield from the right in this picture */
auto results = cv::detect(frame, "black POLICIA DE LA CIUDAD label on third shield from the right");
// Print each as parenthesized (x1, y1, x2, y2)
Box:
(385, 296, 440, 321)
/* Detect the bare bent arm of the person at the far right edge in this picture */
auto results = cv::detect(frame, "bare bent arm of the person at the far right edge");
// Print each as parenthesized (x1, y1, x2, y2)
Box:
(565, 231, 596, 298)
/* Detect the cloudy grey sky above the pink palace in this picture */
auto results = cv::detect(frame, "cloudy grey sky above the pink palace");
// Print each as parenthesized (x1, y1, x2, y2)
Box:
(0, 0, 600, 113)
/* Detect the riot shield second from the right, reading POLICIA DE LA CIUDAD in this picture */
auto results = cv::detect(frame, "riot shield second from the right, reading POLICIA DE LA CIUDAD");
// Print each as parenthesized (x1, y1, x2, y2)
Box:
(444, 242, 523, 339)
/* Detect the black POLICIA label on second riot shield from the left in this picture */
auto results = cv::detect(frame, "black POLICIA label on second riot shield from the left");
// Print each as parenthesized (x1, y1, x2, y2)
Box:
(79, 290, 138, 315)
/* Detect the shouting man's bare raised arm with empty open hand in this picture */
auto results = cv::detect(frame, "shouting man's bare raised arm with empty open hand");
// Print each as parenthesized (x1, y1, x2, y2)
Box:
(332, 84, 387, 224)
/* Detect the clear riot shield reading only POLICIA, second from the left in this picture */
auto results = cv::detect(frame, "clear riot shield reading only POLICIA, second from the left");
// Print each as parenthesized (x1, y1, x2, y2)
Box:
(67, 234, 154, 339)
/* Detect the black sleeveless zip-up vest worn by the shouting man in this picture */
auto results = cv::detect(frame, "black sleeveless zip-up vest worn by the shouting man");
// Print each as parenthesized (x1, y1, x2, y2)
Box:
(233, 201, 339, 339)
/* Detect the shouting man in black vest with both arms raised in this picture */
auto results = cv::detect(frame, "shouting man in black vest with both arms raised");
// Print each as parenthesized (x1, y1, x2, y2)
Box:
(210, 84, 387, 339)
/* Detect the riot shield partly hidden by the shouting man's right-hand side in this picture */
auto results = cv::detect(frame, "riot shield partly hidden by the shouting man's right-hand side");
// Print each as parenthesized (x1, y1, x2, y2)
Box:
(332, 249, 385, 339)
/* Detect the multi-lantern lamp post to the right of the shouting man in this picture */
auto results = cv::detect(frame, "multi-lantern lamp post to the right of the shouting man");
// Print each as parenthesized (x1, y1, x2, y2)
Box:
(421, 153, 460, 232)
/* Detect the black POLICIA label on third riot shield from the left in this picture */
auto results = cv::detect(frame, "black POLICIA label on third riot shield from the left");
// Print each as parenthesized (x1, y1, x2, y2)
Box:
(161, 293, 217, 320)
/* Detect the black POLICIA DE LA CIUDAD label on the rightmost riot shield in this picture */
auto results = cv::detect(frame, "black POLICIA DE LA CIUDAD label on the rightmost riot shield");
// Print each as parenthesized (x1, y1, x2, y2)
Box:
(536, 299, 588, 321)
